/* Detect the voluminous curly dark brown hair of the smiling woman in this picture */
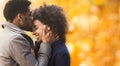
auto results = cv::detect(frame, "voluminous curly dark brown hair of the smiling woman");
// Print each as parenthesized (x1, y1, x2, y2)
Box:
(33, 4, 68, 40)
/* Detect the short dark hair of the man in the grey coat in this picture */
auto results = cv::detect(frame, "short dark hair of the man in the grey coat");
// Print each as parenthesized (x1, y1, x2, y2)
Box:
(3, 0, 31, 21)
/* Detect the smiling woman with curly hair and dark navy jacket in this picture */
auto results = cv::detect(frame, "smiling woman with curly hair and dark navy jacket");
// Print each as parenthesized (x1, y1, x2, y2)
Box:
(33, 5, 70, 66)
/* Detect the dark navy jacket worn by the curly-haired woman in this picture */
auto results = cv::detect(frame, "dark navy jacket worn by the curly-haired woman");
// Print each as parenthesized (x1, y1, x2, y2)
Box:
(48, 39, 70, 66)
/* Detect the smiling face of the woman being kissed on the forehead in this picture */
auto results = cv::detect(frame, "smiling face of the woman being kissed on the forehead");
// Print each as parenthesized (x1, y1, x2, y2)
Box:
(33, 20, 44, 42)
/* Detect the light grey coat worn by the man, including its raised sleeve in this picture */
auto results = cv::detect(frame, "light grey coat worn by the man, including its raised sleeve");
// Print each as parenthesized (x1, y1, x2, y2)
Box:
(0, 22, 51, 66)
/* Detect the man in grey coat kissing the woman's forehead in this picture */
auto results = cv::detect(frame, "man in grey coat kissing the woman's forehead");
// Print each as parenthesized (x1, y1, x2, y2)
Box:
(0, 0, 56, 66)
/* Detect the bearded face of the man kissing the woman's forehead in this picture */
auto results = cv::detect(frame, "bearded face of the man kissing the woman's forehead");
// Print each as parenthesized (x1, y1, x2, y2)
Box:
(21, 10, 33, 31)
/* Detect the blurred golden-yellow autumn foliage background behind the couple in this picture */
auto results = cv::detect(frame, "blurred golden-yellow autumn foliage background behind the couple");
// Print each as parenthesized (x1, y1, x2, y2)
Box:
(0, 0, 120, 66)
